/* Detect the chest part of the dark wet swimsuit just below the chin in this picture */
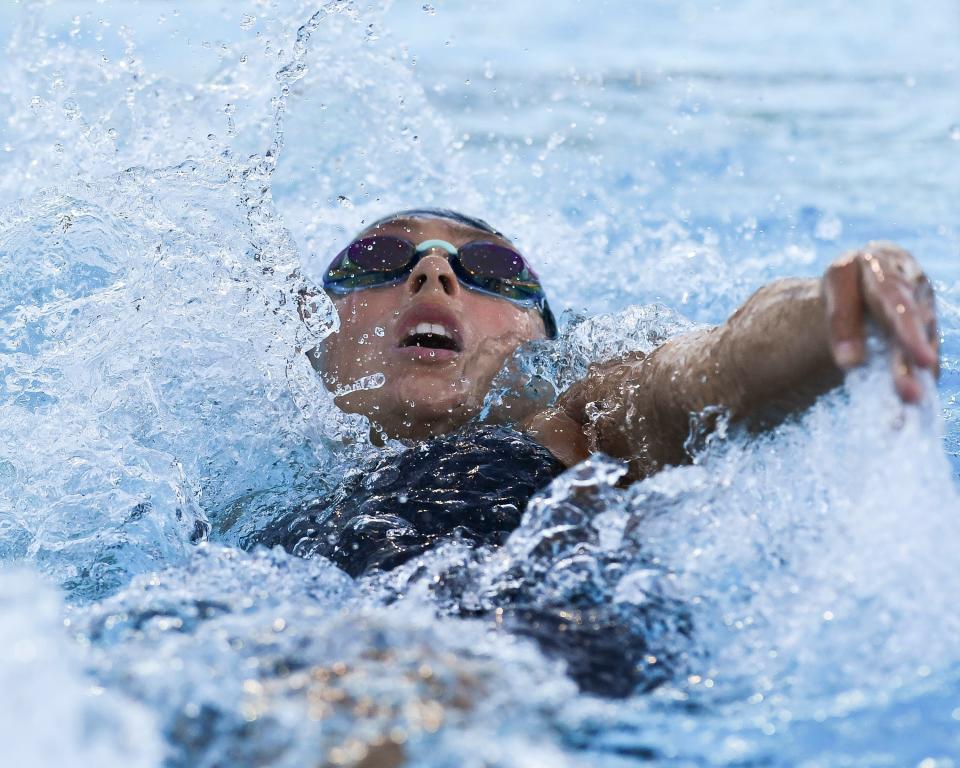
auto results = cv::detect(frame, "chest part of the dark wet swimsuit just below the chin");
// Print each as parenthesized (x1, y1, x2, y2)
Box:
(258, 426, 564, 576)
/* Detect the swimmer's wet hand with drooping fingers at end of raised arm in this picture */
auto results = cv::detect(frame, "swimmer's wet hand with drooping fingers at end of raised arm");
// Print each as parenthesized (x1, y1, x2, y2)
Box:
(822, 242, 940, 403)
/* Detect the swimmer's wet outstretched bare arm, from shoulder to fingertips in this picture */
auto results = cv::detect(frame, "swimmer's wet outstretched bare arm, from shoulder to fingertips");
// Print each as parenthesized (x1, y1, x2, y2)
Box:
(527, 243, 939, 477)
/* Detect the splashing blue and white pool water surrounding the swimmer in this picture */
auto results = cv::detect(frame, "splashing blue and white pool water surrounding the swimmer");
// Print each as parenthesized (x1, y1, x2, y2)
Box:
(0, 0, 960, 768)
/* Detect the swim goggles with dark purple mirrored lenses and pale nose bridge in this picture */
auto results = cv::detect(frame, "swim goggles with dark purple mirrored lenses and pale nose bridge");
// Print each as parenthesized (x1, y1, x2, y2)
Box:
(323, 235, 557, 339)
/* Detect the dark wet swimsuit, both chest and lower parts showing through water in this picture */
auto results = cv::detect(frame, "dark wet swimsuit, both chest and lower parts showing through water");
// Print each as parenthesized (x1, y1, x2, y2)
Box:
(256, 426, 686, 696)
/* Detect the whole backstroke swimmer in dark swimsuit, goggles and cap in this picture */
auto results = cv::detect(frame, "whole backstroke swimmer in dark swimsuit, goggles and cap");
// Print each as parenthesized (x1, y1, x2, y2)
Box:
(262, 210, 938, 697)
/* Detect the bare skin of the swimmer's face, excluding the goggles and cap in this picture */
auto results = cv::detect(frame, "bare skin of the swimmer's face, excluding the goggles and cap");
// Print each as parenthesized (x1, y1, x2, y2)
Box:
(320, 217, 545, 439)
